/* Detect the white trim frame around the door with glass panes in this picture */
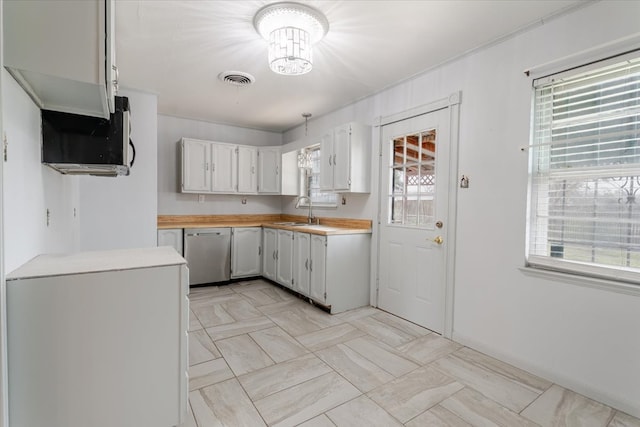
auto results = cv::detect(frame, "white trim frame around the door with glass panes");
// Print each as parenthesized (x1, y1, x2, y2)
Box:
(371, 91, 462, 339)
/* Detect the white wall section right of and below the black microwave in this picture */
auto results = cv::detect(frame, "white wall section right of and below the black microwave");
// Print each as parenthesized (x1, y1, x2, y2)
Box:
(79, 90, 158, 250)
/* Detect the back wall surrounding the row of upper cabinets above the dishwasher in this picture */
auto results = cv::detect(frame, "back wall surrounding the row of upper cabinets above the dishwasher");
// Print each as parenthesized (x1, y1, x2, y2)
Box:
(158, 115, 282, 215)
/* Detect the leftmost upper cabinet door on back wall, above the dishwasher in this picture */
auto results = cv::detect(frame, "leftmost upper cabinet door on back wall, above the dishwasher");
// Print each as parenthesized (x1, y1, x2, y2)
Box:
(182, 138, 211, 193)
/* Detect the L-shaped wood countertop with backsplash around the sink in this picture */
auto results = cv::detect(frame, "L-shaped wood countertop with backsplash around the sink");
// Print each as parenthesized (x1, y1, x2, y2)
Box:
(158, 214, 371, 236)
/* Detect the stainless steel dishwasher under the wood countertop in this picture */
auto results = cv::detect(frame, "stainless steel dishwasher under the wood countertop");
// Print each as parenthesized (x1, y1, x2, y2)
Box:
(184, 228, 231, 285)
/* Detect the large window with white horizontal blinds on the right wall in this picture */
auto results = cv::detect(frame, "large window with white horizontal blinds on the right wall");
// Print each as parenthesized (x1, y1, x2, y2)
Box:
(527, 55, 640, 283)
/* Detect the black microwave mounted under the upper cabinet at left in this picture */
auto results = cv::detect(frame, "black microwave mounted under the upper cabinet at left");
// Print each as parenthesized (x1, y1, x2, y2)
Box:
(41, 96, 135, 176)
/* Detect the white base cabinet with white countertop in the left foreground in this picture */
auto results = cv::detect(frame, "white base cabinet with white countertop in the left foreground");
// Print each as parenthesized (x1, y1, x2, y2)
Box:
(6, 247, 189, 427)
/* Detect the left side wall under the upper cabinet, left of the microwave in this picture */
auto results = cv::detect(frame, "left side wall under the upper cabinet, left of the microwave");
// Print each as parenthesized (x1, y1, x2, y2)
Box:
(2, 68, 78, 273)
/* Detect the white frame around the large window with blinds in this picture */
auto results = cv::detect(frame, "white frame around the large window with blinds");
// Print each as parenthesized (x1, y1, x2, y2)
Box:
(525, 51, 640, 292)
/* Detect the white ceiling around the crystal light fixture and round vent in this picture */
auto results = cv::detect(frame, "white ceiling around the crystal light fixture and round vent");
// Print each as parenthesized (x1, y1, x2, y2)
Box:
(116, 0, 584, 131)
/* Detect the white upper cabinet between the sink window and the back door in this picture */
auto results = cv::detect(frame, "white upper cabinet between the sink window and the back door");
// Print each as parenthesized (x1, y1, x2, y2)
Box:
(320, 123, 371, 193)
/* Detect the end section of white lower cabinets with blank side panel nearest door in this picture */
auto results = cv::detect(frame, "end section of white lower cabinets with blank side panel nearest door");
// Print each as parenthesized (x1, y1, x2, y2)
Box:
(293, 232, 371, 313)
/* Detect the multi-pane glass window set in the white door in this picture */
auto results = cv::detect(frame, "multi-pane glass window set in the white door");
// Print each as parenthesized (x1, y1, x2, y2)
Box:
(389, 129, 436, 228)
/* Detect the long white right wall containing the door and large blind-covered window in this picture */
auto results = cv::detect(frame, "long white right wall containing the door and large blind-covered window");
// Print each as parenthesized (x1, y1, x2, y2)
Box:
(283, 1, 640, 416)
